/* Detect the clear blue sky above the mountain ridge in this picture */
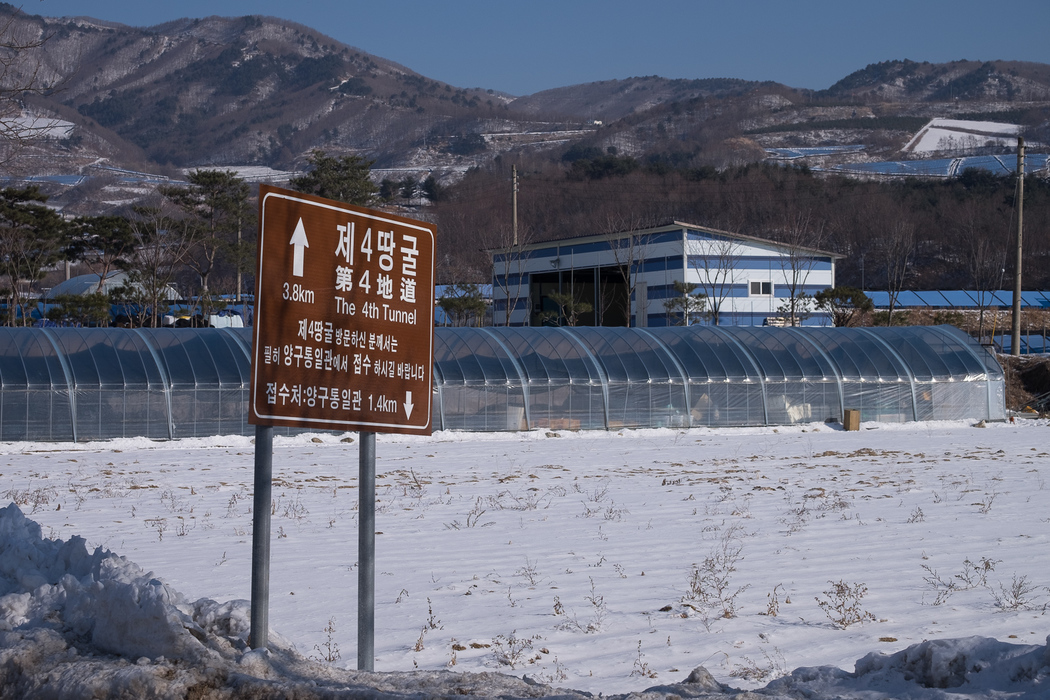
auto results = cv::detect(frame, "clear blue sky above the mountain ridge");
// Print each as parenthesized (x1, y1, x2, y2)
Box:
(32, 0, 1050, 96)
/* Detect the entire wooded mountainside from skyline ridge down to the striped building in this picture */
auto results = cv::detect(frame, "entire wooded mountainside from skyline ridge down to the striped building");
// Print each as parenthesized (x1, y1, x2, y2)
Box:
(0, 4, 1050, 316)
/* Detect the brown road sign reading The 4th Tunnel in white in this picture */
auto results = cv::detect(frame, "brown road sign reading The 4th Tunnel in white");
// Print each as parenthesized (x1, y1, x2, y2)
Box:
(249, 186, 434, 434)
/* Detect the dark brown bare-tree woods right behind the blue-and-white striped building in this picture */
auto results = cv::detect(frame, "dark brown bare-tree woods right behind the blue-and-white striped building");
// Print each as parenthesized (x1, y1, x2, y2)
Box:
(435, 153, 1050, 290)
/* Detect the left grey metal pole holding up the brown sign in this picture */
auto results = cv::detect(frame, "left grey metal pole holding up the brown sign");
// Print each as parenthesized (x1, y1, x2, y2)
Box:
(248, 425, 273, 649)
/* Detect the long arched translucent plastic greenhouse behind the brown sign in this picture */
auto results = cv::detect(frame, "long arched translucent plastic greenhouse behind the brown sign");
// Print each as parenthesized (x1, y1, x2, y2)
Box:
(0, 326, 1006, 441)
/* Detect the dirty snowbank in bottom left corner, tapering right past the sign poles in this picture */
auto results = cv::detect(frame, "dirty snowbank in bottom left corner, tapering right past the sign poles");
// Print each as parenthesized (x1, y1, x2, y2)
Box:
(0, 504, 582, 699)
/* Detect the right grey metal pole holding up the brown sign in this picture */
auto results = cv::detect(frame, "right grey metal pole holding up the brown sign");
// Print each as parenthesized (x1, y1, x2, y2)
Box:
(357, 430, 376, 671)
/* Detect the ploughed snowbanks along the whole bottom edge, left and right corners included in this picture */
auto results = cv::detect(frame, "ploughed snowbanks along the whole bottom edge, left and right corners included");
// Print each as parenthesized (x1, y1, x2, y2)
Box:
(0, 504, 1050, 700)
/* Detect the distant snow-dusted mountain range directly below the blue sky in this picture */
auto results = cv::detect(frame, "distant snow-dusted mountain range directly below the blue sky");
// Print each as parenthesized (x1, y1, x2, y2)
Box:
(8, 3, 1050, 179)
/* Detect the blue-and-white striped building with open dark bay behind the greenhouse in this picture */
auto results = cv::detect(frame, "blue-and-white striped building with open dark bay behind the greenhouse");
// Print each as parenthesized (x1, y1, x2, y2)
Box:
(489, 221, 841, 327)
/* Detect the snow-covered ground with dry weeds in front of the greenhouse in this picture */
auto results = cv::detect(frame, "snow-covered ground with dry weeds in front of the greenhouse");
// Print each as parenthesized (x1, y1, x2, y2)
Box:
(0, 420, 1050, 699)
